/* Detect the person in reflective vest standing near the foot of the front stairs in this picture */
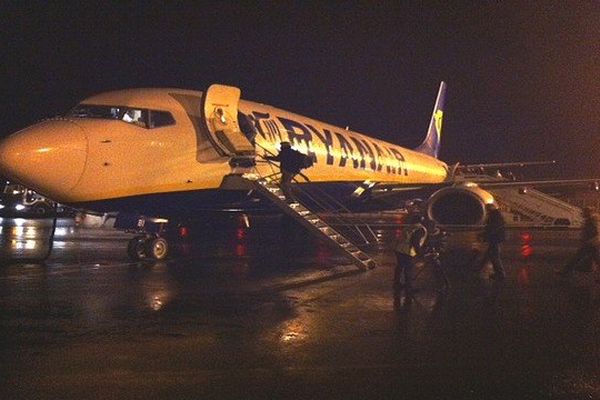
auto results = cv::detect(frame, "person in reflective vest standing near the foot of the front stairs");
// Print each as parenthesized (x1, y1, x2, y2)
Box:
(394, 210, 427, 306)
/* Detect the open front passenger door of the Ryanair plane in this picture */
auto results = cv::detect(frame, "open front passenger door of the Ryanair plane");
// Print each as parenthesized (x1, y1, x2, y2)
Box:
(202, 85, 255, 156)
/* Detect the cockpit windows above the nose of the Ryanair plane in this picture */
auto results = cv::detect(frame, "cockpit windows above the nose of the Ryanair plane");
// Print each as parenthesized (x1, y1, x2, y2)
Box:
(67, 104, 175, 129)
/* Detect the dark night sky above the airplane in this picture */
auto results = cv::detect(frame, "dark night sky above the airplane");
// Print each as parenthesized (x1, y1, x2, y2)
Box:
(0, 0, 600, 177)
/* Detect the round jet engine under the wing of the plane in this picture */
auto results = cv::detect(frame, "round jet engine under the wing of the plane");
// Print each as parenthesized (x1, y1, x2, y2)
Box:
(427, 182, 495, 225)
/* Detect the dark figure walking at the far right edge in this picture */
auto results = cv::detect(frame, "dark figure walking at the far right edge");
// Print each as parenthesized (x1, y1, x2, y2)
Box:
(557, 207, 600, 276)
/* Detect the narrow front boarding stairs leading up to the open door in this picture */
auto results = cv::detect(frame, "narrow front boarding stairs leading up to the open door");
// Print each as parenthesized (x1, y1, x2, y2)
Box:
(222, 173, 376, 270)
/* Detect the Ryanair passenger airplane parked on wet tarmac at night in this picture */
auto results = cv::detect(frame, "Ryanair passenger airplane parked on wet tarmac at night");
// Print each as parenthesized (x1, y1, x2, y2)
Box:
(0, 82, 596, 257)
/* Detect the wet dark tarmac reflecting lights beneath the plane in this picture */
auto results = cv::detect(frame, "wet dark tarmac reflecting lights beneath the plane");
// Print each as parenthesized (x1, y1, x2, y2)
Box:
(0, 219, 600, 399)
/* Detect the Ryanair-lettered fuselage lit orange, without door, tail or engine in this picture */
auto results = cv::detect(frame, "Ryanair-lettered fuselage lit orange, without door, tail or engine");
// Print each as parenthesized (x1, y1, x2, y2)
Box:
(0, 85, 448, 214)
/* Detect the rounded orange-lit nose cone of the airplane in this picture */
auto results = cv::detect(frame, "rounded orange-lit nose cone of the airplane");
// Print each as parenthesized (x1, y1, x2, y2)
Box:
(0, 120, 87, 201)
